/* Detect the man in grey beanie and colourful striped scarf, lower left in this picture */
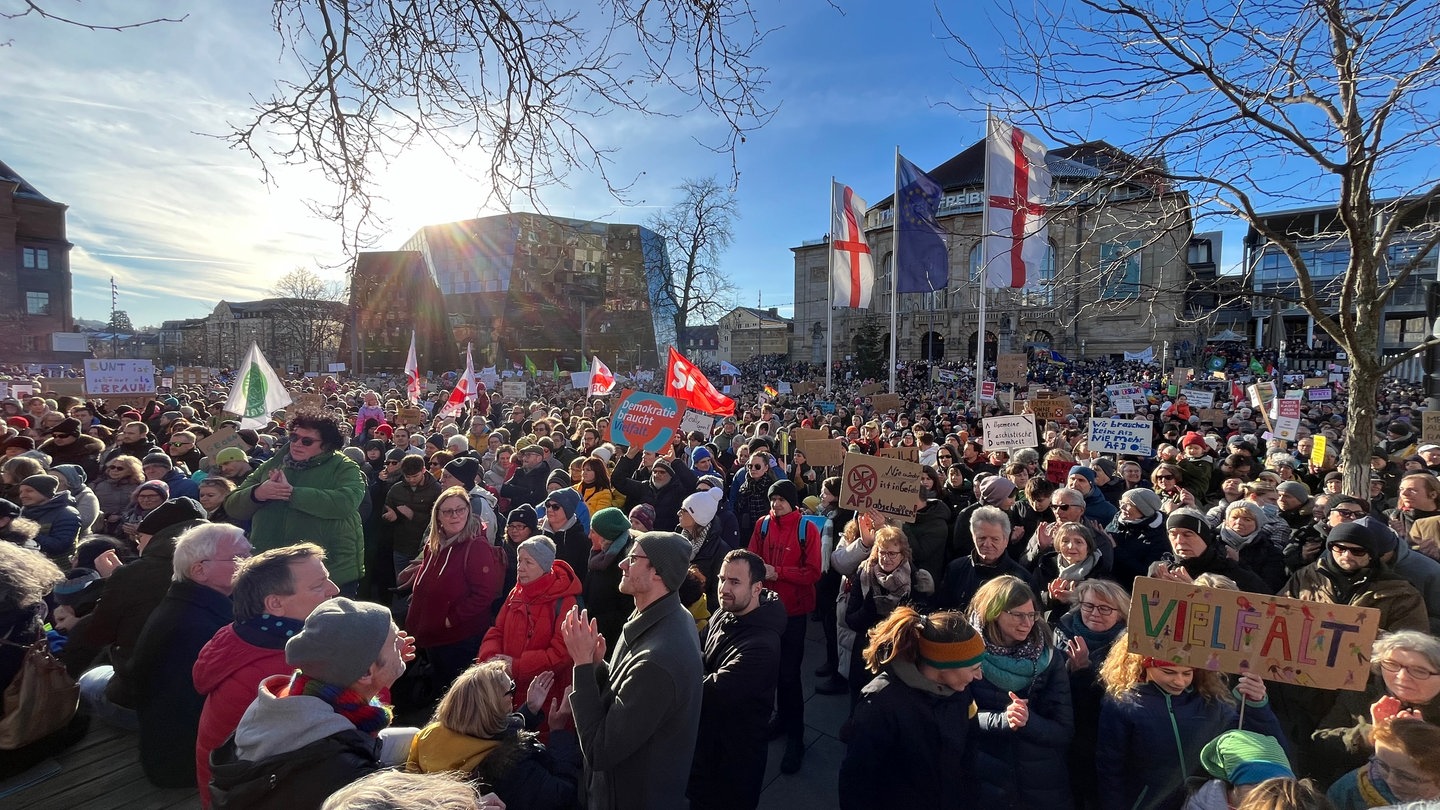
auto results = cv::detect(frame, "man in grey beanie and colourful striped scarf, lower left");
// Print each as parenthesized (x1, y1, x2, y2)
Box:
(210, 597, 416, 810)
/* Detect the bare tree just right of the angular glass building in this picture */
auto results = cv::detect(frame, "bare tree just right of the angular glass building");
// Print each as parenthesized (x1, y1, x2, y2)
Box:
(647, 176, 740, 344)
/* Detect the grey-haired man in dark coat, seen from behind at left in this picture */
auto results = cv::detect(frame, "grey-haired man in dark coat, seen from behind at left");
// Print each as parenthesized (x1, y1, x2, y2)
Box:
(131, 523, 251, 787)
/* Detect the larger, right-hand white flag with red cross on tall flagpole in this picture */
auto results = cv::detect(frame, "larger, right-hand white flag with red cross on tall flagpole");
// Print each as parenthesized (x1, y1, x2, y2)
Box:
(984, 118, 1050, 287)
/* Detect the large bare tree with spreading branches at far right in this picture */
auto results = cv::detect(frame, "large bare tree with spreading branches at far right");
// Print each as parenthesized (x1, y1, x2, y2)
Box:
(950, 0, 1440, 493)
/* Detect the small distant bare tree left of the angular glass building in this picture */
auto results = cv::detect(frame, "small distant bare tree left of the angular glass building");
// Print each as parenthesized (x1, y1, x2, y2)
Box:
(274, 267, 346, 370)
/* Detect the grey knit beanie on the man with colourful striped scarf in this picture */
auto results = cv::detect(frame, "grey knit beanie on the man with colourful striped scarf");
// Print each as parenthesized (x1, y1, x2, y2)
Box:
(285, 597, 392, 686)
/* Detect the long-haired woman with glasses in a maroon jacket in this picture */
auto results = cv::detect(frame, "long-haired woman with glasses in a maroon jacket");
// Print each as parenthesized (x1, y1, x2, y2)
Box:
(405, 487, 505, 683)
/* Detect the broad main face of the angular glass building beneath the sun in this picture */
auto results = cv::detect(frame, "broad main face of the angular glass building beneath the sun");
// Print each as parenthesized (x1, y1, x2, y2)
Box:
(402, 213, 675, 370)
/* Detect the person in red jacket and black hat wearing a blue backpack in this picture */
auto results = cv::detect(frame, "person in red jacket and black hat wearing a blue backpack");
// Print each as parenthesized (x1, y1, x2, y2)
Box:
(749, 479, 821, 774)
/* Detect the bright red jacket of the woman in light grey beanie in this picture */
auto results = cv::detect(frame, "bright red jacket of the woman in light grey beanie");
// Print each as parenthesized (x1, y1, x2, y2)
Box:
(475, 559, 580, 705)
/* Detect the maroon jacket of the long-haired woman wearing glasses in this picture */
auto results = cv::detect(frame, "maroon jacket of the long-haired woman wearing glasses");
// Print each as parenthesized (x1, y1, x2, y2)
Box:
(405, 520, 505, 647)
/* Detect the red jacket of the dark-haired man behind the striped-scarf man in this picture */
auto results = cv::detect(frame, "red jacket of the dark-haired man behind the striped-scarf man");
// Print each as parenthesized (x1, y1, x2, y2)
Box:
(190, 624, 294, 807)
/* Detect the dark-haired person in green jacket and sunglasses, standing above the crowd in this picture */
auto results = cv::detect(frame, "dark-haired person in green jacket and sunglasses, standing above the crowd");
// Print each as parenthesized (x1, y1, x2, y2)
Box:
(225, 412, 366, 597)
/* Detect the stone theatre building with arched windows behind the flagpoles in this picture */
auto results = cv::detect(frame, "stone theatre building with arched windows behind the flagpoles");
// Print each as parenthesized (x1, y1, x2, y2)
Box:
(792, 141, 1195, 362)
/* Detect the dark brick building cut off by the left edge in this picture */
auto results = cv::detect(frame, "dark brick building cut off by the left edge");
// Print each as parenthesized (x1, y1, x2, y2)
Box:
(0, 157, 79, 363)
